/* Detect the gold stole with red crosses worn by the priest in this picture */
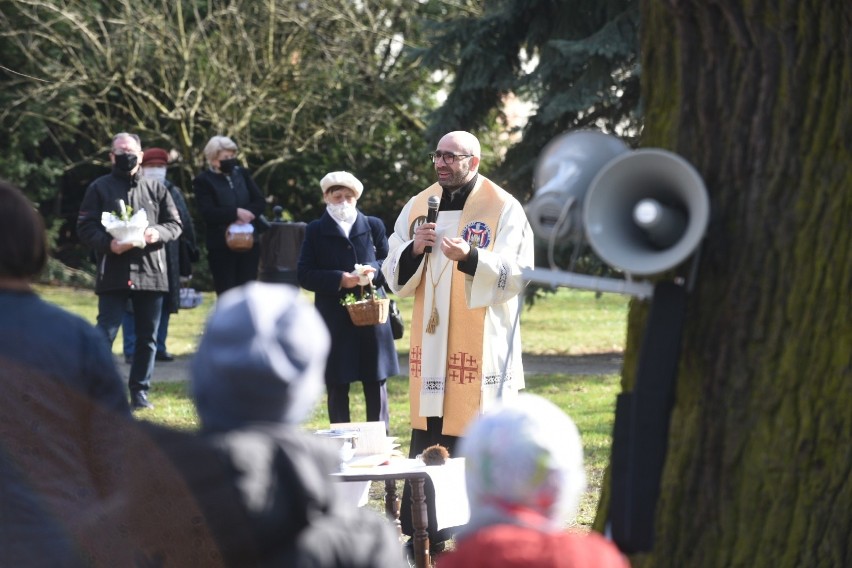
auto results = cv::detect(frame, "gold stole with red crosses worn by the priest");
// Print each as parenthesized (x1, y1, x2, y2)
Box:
(408, 175, 508, 436)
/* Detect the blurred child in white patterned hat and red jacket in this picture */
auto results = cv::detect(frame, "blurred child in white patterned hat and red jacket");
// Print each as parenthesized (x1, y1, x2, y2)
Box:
(439, 394, 629, 568)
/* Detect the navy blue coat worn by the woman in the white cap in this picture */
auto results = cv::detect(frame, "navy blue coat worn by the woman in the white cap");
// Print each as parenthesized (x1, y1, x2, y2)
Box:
(298, 212, 399, 385)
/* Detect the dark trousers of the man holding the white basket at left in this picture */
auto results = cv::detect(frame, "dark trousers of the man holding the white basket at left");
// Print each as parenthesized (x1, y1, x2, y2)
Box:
(97, 290, 165, 395)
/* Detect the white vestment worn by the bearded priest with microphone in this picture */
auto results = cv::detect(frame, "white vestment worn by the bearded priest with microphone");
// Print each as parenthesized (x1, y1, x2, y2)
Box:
(382, 176, 534, 435)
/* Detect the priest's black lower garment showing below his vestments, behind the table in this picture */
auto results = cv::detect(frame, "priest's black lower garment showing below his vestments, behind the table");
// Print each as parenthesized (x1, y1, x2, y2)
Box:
(399, 416, 461, 545)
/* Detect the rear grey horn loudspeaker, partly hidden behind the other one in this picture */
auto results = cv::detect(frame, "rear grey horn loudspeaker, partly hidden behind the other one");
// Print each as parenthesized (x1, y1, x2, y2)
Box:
(526, 130, 630, 241)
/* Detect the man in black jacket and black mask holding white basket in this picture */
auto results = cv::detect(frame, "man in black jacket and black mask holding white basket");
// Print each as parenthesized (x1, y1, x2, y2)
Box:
(77, 132, 181, 410)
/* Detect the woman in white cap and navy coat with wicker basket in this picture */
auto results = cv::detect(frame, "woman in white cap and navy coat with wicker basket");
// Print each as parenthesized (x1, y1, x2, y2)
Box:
(298, 172, 399, 430)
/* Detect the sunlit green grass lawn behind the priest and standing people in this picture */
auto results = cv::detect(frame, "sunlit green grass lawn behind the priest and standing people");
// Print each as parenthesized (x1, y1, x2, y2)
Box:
(37, 286, 628, 527)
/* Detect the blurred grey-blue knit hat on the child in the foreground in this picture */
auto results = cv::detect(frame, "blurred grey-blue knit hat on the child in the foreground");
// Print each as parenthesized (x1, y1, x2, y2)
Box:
(192, 282, 330, 431)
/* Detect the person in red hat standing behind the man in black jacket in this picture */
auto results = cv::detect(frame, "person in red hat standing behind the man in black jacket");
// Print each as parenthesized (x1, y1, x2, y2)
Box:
(121, 148, 198, 363)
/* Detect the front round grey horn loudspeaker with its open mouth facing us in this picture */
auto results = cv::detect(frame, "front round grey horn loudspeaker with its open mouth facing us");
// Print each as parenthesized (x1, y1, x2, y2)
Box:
(583, 149, 710, 276)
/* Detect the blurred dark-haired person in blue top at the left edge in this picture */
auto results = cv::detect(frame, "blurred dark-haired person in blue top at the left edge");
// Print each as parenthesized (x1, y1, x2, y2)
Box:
(0, 181, 130, 567)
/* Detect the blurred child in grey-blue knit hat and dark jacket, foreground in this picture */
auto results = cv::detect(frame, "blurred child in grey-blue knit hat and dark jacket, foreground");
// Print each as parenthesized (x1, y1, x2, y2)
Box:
(113, 282, 404, 568)
